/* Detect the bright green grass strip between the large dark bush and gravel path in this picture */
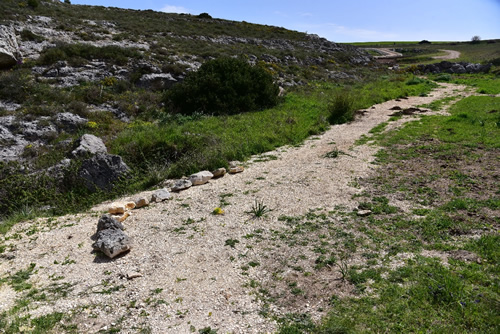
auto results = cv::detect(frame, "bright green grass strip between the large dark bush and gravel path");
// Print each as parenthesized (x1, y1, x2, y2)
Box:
(111, 76, 434, 185)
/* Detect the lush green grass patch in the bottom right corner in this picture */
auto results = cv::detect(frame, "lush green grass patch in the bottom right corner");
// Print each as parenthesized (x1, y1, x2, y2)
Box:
(312, 258, 498, 333)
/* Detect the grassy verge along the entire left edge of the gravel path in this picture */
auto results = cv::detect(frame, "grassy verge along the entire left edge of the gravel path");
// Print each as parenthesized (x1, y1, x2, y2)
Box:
(0, 75, 433, 233)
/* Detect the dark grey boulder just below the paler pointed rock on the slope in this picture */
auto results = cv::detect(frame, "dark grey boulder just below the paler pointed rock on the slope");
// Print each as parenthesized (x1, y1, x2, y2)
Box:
(78, 153, 130, 191)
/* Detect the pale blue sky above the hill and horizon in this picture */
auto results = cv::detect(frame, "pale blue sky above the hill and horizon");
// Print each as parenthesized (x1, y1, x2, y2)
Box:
(67, 0, 500, 42)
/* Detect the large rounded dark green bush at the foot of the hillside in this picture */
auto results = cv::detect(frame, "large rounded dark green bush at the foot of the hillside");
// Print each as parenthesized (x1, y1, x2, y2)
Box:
(165, 57, 279, 115)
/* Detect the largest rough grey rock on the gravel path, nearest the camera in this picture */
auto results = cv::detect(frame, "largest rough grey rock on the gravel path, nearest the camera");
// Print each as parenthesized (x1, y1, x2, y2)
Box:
(92, 215, 132, 259)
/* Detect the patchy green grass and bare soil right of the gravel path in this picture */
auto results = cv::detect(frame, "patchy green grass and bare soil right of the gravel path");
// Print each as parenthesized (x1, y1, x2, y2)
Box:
(280, 97, 500, 333)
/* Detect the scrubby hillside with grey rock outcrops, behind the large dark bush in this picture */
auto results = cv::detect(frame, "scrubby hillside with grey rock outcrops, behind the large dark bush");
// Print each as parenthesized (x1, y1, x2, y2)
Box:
(0, 0, 371, 219)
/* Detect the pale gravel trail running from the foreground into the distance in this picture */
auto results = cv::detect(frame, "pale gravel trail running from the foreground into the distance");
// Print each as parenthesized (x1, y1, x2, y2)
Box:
(0, 83, 474, 333)
